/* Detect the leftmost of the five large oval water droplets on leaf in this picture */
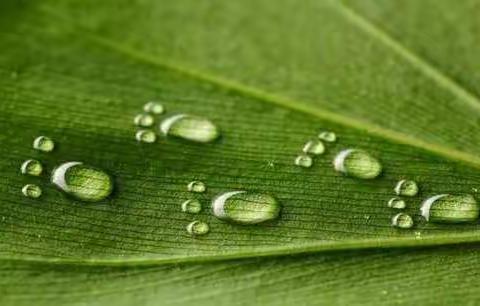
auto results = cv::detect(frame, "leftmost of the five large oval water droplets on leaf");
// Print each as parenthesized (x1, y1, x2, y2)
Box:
(52, 162, 113, 202)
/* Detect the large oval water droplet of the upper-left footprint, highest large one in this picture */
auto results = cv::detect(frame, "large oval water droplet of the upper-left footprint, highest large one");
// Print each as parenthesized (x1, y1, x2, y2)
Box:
(160, 114, 220, 143)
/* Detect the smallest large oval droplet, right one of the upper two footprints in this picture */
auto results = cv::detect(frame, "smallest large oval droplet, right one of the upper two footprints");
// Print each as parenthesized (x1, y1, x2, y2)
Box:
(333, 149, 382, 179)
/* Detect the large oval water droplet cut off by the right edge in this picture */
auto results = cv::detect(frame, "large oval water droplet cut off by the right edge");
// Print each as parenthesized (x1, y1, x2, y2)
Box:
(420, 194, 479, 223)
